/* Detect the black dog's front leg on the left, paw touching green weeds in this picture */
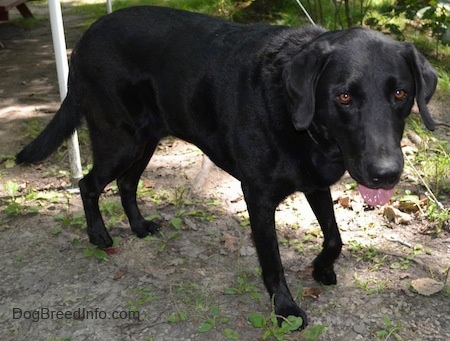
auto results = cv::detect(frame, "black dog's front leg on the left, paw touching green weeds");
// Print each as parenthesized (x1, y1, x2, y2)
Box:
(242, 185, 307, 328)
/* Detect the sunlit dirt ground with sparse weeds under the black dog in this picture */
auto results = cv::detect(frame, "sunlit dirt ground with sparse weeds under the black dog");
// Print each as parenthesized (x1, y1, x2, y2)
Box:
(0, 3, 450, 341)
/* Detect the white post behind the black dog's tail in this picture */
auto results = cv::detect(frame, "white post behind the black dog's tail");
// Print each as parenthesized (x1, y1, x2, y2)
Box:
(48, 0, 83, 187)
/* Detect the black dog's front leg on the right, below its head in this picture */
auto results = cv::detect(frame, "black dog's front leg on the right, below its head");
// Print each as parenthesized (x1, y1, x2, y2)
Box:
(305, 188, 342, 285)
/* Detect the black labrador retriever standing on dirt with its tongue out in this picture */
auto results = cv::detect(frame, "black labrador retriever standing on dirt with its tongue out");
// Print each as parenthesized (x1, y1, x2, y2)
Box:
(17, 7, 437, 326)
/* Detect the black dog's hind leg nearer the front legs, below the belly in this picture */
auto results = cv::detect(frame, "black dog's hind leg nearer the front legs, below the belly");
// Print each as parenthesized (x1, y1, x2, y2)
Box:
(117, 140, 160, 238)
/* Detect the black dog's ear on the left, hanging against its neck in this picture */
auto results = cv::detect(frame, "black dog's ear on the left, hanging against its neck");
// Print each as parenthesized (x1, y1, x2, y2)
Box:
(283, 41, 331, 131)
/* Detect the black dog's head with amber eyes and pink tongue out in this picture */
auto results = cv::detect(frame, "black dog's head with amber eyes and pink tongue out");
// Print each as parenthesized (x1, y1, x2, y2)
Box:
(284, 28, 437, 204)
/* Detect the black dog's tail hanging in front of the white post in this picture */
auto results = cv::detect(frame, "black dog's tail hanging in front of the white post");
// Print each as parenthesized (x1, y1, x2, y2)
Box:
(16, 96, 82, 164)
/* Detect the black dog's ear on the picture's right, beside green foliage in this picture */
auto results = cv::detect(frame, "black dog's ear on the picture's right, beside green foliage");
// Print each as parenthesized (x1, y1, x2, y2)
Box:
(408, 44, 438, 131)
